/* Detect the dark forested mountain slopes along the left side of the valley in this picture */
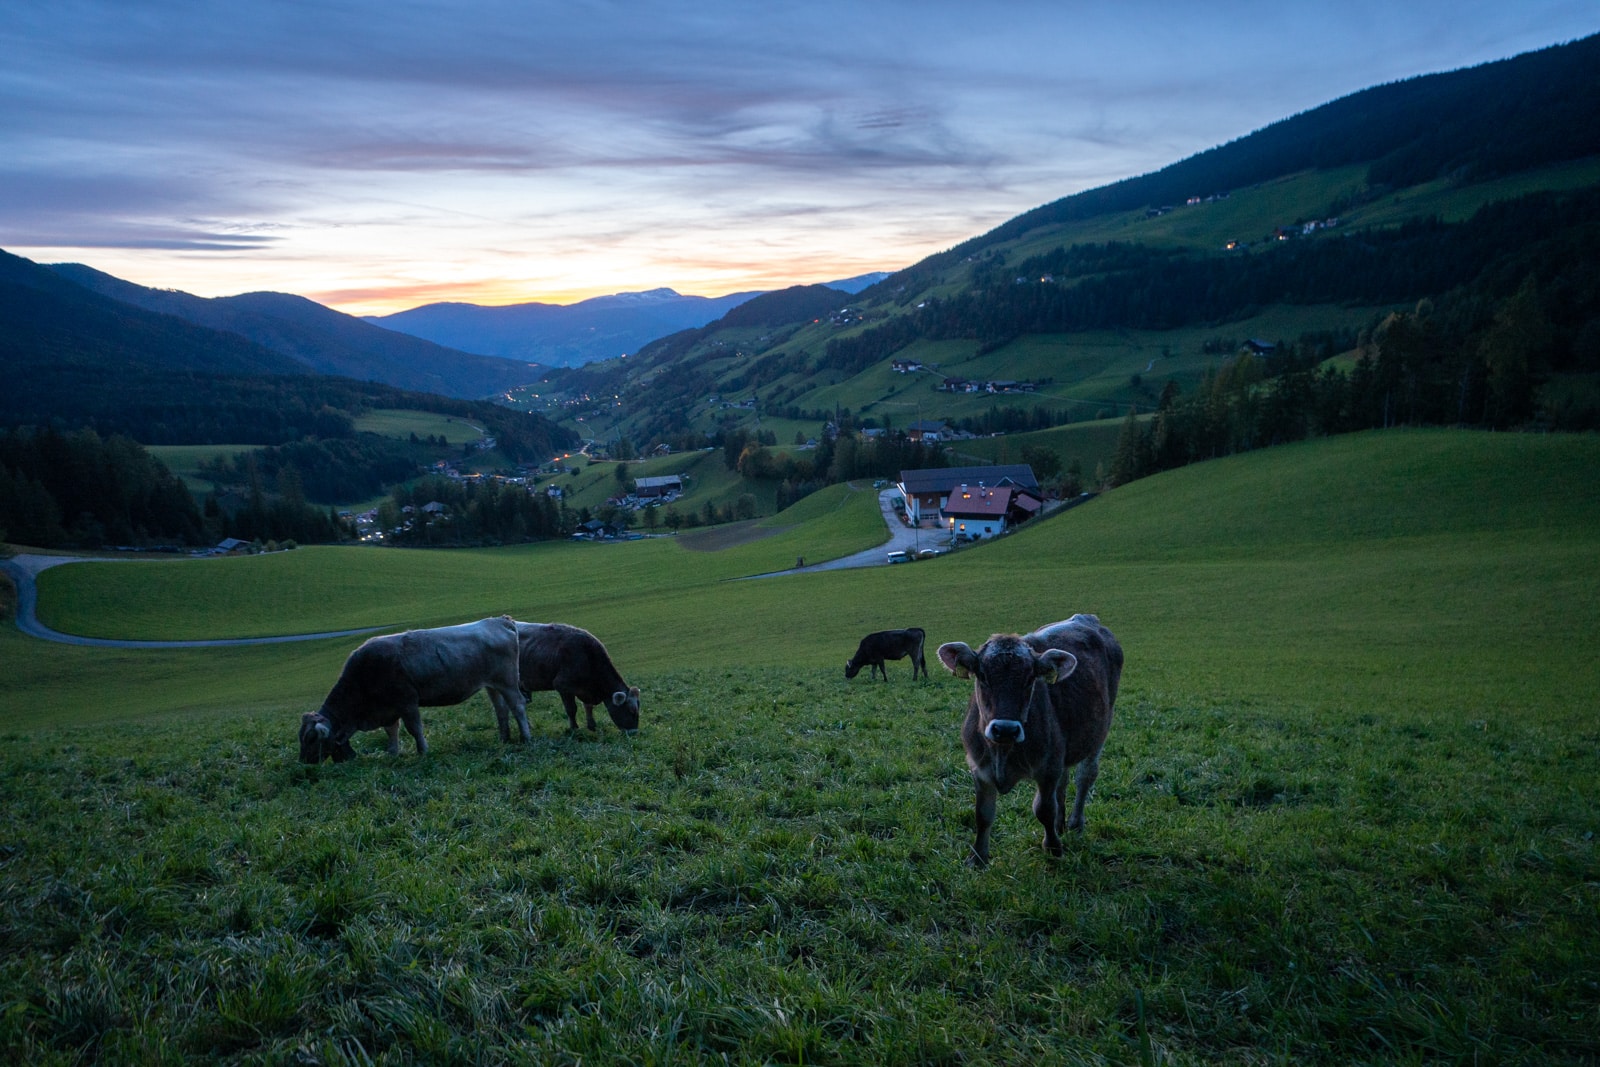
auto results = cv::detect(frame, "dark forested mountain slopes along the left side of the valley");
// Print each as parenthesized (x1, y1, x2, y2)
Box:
(0, 251, 573, 459)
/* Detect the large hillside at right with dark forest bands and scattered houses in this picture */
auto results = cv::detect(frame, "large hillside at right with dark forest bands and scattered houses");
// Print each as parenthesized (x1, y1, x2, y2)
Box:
(541, 37, 1600, 460)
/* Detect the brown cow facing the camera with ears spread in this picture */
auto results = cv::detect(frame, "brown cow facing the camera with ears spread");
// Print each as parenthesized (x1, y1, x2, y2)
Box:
(939, 614, 1122, 867)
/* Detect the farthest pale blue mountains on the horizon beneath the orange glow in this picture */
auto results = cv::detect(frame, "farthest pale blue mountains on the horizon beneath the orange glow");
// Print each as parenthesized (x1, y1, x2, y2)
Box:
(366, 270, 888, 366)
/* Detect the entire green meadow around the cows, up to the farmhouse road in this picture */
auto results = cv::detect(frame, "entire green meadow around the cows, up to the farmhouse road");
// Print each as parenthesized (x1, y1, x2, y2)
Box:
(0, 430, 1600, 1064)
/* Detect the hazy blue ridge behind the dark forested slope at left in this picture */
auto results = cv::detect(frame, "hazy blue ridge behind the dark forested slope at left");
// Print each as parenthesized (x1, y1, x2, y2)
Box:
(43, 261, 544, 400)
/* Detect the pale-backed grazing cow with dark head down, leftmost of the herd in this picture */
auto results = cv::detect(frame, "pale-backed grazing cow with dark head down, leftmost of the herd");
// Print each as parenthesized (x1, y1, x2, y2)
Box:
(299, 616, 530, 763)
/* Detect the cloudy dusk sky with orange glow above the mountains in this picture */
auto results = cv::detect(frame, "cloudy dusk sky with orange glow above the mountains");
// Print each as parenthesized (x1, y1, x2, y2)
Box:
(0, 0, 1600, 314)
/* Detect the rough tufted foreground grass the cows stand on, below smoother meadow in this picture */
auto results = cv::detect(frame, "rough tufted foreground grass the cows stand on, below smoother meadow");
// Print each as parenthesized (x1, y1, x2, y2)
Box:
(0, 670, 1600, 1064)
